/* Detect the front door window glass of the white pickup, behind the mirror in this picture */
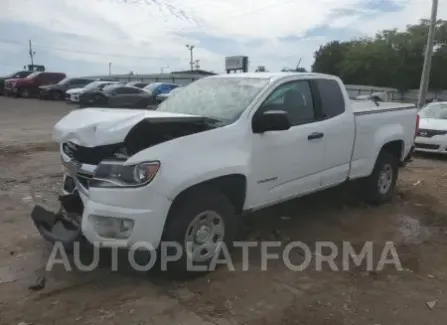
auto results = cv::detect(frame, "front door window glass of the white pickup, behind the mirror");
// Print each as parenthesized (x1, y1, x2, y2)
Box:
(260, 80, 315, 125)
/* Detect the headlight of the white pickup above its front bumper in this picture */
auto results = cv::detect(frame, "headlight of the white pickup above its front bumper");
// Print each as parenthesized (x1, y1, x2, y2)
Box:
(89, 161, 160, 187)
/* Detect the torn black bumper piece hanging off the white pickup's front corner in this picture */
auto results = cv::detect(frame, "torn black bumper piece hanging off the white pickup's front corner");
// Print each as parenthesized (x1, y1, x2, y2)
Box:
(31, 194, 83, 246)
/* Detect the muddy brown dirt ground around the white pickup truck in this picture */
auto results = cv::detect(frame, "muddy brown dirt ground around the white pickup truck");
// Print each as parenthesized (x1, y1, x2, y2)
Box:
(0, 97, 447, 325)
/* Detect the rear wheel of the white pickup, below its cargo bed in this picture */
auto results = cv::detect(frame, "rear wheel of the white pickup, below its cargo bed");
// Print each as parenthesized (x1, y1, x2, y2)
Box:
(360, 151, 399, 204)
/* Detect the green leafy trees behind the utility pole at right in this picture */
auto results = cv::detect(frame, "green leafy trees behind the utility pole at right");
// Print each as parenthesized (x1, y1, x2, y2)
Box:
(312, 20, 447, 91)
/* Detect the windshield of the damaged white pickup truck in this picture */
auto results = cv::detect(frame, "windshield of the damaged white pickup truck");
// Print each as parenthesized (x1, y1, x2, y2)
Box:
(157, 77, 269, 123)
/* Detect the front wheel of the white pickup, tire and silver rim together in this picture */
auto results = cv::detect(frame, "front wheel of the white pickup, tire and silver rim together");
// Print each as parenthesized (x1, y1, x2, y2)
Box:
(159, 187, 237, 273)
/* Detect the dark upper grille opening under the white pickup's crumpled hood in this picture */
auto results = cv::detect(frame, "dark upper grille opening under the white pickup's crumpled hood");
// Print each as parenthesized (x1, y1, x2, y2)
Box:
(62, 142, 122, 165)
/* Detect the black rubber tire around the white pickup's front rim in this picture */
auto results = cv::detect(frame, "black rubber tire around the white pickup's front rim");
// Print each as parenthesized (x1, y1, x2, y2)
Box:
(158, 186, 237, 275)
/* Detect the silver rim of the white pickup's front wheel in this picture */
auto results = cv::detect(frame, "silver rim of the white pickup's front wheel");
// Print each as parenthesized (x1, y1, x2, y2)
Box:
(185, 211, 225, 262)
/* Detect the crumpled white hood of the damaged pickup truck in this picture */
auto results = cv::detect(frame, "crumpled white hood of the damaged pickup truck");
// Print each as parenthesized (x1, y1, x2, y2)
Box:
(53, 108, 200, 147)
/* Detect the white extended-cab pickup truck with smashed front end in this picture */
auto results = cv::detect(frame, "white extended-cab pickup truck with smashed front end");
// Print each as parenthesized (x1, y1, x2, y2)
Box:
(32, 73, 418, 269)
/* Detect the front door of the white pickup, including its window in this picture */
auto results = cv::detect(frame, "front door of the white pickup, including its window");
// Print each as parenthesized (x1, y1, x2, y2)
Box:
(247, 79, 326, 208)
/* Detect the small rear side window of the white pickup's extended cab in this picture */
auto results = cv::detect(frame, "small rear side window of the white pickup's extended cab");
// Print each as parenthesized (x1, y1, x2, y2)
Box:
(315, 79, 345, 119)
